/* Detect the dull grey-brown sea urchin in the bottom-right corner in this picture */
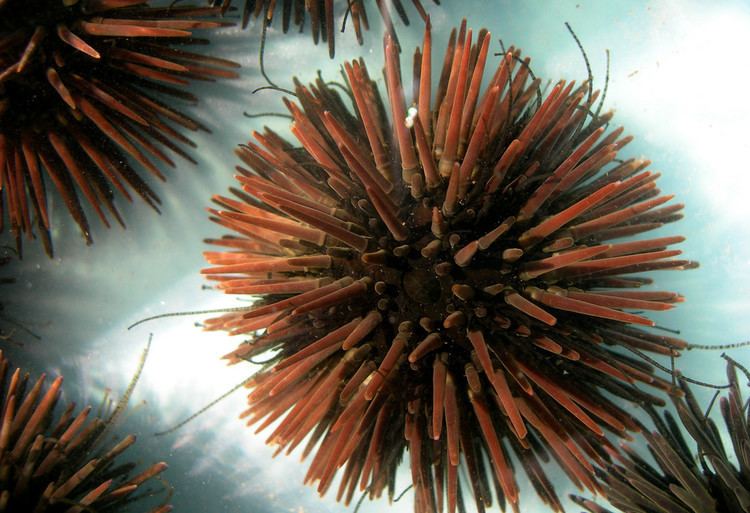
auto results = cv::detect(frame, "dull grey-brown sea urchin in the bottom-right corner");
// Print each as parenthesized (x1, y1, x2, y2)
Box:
(573, 360, 750, 513)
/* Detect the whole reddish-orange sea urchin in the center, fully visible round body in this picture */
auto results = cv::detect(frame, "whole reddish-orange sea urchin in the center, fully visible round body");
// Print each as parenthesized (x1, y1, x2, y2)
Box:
(202, 21, 693, 513)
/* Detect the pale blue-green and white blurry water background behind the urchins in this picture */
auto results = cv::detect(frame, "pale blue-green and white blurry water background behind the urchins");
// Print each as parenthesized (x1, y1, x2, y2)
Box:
(0, 0, 750, 513)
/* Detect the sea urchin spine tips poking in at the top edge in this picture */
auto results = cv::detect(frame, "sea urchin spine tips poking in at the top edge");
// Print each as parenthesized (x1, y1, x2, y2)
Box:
(211, 0, 440, 58)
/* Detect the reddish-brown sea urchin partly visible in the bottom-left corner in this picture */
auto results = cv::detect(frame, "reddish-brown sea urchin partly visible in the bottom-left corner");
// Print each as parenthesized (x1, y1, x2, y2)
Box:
(0, 351, 172, 513)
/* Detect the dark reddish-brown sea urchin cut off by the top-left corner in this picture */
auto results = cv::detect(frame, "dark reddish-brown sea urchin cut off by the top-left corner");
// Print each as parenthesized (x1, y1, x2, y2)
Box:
(0, 0, 237, 253)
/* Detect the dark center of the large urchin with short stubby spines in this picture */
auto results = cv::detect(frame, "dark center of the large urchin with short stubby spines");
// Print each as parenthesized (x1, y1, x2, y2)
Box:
(357, 200, 524, 316)
